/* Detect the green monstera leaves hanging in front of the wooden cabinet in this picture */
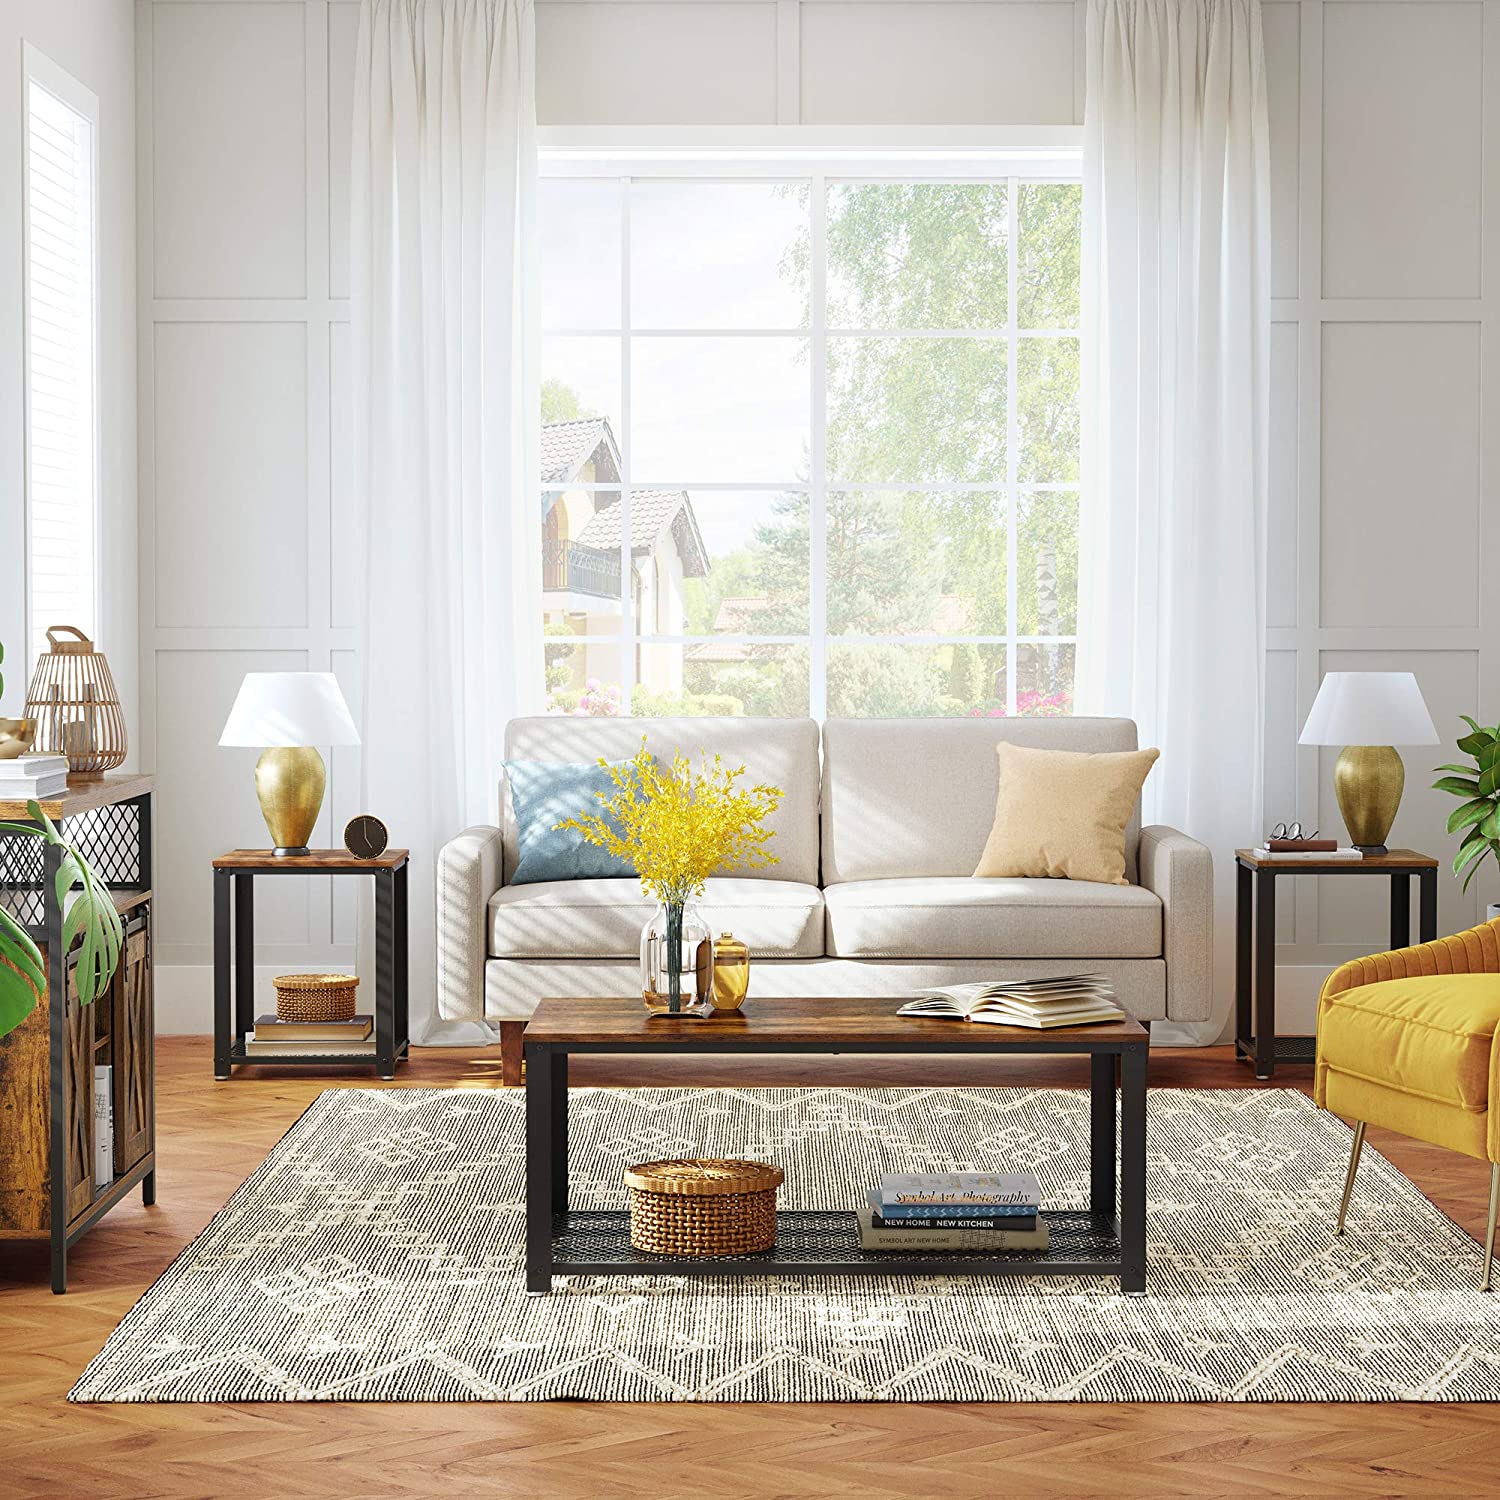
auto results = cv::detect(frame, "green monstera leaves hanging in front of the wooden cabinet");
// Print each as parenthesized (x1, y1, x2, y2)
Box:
(0, 803, 125, 1037)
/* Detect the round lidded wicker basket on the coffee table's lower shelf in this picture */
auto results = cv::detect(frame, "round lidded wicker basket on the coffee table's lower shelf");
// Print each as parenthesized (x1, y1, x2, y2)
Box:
(626, 1158, 783, 1256)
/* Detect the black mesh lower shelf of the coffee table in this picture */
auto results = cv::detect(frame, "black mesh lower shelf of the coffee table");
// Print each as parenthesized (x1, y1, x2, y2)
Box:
(552, 1209, 1122, 1277)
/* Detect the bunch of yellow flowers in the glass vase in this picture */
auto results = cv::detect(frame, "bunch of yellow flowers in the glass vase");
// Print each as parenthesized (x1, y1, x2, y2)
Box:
(557, 737, 782, 905)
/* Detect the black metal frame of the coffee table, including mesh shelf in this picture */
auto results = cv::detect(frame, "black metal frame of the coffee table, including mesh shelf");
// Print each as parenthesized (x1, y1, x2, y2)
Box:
(525, 1020, 1151, 1296)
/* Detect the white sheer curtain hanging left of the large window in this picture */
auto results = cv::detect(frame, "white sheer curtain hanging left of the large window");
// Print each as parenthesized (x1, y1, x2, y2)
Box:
(351, 0, 542, 1043)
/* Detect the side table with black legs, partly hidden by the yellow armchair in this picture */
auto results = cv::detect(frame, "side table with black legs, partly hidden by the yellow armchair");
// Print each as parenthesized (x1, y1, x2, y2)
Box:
(1235, 849, 1437, 1079)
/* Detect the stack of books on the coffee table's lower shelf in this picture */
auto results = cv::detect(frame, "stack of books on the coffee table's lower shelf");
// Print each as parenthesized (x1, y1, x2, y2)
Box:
(858, 1172, 1047, 1256)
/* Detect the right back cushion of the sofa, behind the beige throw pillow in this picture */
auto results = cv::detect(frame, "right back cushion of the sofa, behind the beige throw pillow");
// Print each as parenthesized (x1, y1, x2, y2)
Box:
(824, 719, 1140, 885)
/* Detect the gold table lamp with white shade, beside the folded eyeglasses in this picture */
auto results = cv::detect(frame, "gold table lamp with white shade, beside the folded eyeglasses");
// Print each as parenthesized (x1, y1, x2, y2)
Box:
(1298, 672, 1437, 854)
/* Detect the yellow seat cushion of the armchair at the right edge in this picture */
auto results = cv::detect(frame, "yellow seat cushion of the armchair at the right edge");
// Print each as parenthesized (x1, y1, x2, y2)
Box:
(1317, 974, 1500, 1116)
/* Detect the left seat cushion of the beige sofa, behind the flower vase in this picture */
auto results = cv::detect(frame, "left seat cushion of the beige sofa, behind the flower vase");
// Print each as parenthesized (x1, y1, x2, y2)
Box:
(489, 876, 824, 963)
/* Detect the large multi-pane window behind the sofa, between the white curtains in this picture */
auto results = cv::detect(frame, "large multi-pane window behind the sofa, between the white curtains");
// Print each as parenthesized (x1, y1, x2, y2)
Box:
(542, 155, 1080, 719)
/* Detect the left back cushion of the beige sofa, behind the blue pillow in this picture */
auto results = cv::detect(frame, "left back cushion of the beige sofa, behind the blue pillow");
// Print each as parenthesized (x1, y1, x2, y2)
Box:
(500, 714, 822, 882)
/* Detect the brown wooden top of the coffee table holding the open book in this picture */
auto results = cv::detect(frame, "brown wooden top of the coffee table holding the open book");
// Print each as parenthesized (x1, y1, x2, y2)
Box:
(525, 996, 1151, 1052)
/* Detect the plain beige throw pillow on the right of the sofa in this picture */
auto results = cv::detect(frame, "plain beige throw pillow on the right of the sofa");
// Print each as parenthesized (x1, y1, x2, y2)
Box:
(974, 740, 1161, 885)
